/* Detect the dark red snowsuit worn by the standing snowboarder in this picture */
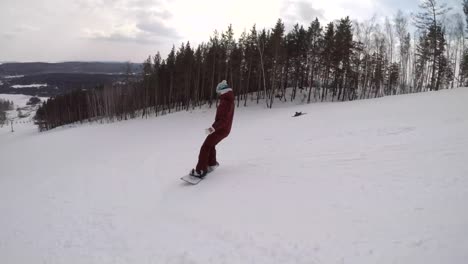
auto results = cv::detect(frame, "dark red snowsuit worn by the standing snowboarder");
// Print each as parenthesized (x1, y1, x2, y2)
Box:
(196, 91, 234, 171)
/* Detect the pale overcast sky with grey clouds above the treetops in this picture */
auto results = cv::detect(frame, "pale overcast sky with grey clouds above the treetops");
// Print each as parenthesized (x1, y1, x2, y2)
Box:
(0, 0, 461, 62)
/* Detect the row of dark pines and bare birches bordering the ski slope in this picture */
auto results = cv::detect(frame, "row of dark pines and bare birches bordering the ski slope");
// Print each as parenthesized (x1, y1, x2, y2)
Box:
(36, 0, 468, 130)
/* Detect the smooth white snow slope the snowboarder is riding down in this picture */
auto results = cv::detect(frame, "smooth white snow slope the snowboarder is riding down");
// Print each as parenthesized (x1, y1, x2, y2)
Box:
(0, 88, 468, 264)
